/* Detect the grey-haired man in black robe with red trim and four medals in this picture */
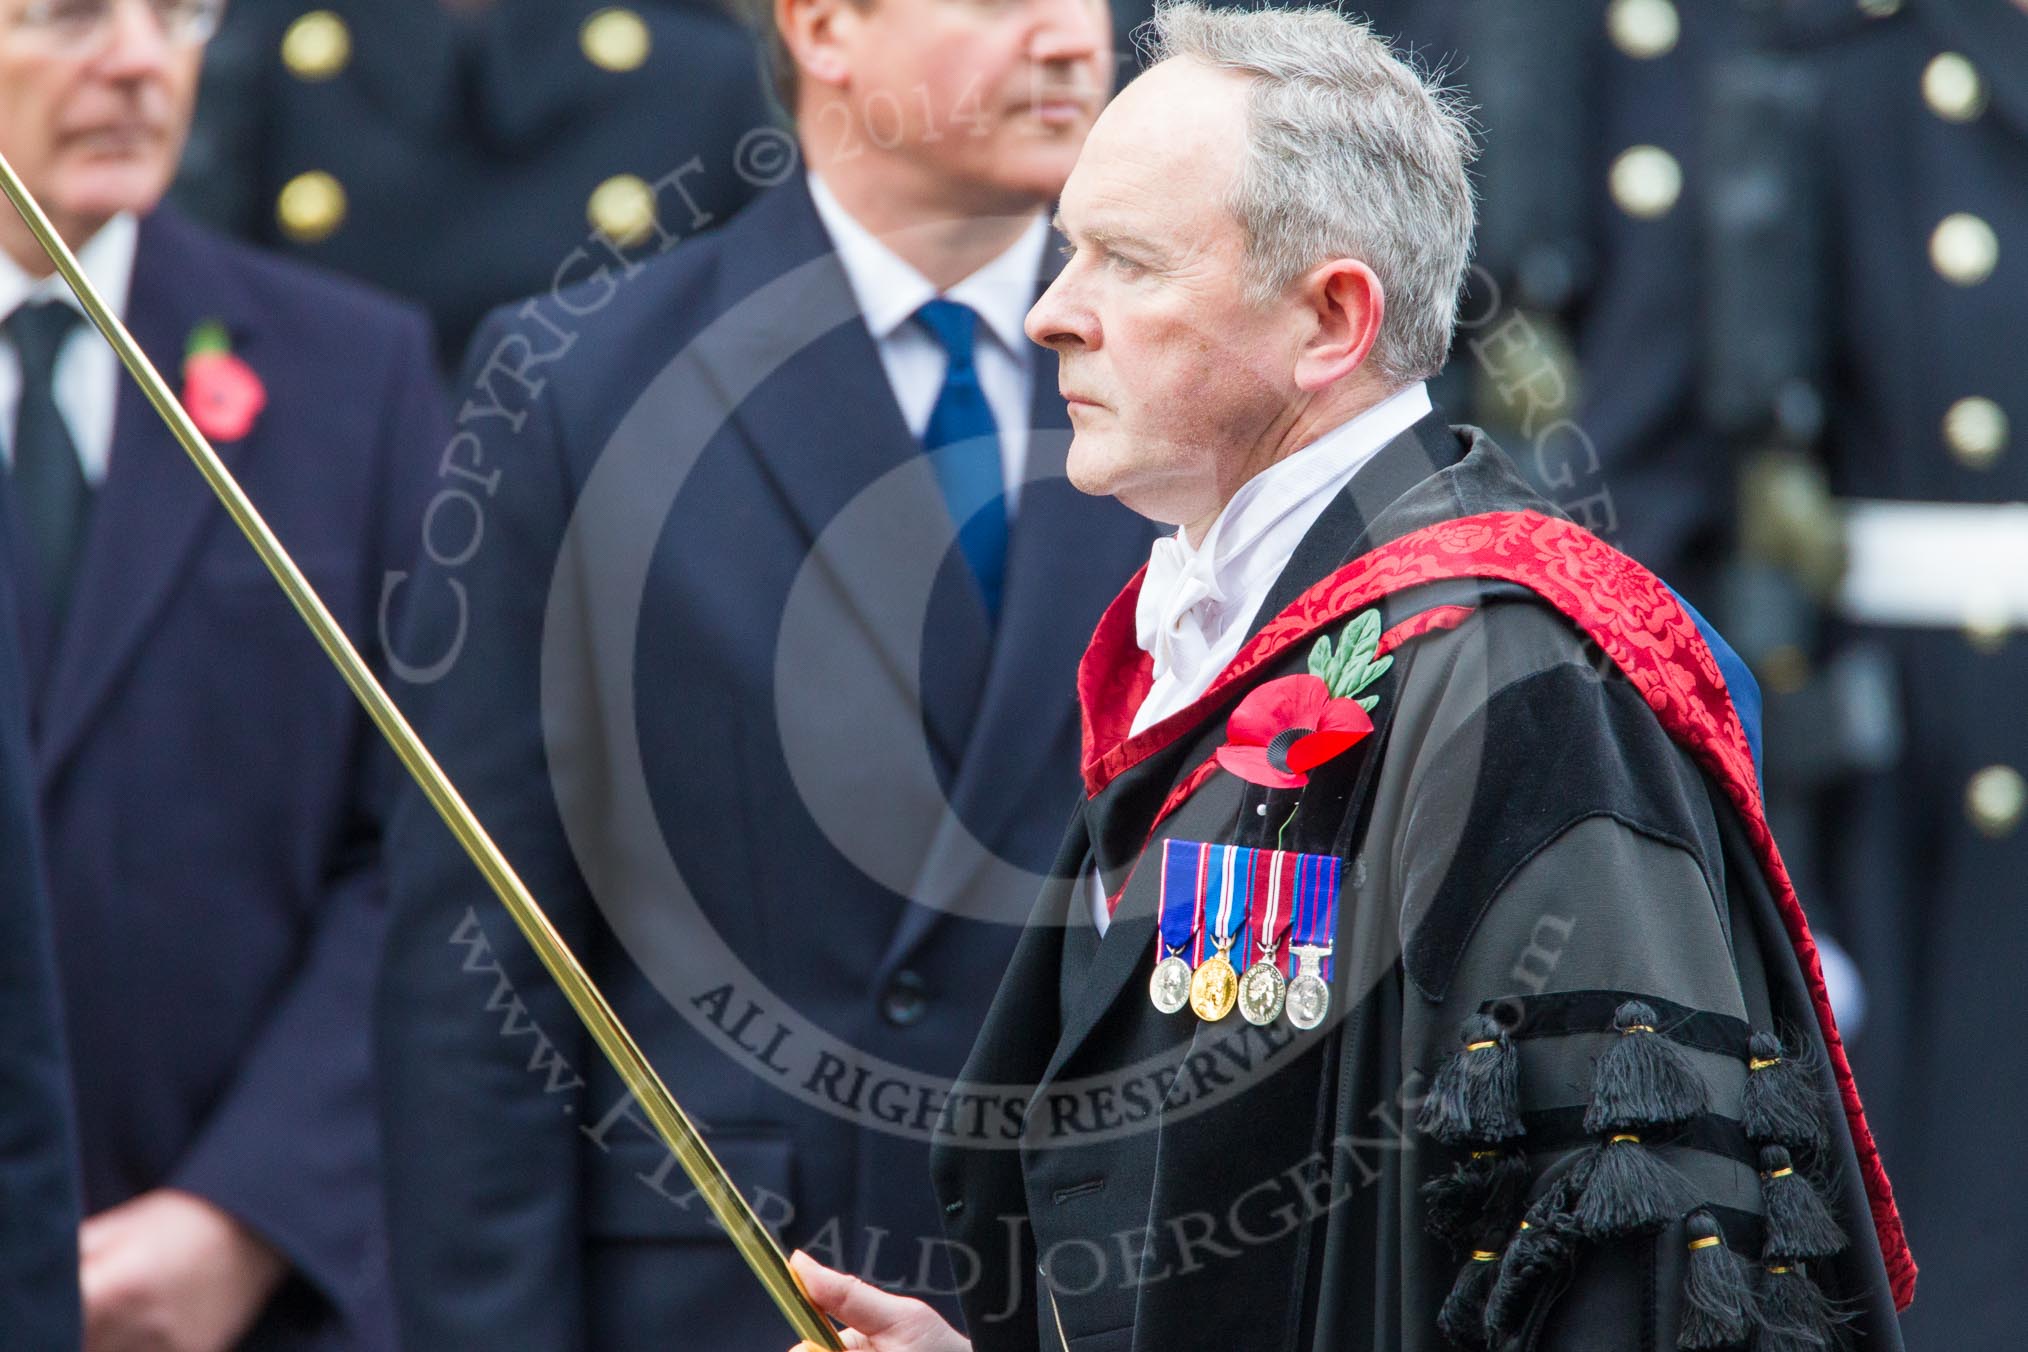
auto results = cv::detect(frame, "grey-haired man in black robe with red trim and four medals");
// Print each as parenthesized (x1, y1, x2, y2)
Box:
(797, 6, 1914, 1352)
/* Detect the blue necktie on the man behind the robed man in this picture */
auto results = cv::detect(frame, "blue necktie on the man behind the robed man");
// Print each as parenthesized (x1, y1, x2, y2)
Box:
(915, 300, 1008, 620)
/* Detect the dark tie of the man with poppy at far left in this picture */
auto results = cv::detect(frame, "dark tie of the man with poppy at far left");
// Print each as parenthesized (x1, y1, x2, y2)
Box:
(0, 302, 91, 618)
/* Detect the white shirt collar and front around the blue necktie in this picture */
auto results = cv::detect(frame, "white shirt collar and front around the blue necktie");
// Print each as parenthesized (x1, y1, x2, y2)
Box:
(809, 174, 1048, 519)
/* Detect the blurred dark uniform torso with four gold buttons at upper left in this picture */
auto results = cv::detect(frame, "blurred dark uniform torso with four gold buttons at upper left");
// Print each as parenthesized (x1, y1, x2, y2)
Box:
(176, 0, 773, 365)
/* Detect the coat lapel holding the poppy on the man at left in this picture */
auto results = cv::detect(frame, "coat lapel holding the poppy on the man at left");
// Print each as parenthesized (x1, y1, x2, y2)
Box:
(37, 213, 262, 784)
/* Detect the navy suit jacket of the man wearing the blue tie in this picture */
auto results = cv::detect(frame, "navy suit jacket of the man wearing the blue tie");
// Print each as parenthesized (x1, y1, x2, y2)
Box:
(379, 180, 1150, 1352)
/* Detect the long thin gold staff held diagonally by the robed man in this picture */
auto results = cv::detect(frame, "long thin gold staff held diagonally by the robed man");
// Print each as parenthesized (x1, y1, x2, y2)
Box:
(0, 154, 846, 1352)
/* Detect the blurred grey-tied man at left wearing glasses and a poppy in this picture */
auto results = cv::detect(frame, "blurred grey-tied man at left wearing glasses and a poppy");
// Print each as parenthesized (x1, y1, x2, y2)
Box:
(0, 0, 444, 1352)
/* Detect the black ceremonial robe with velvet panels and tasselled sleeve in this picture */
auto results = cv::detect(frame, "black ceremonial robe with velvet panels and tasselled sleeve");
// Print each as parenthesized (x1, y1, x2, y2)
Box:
(933, 416, 1912, 1352)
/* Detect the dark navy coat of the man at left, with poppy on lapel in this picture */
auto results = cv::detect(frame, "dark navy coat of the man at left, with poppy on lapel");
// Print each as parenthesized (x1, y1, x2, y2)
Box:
(13, 211, 444, 1346)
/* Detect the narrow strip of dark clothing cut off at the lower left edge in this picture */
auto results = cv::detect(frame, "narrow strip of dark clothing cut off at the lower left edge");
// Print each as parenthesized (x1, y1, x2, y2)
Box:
(0, 488, 81, 1348)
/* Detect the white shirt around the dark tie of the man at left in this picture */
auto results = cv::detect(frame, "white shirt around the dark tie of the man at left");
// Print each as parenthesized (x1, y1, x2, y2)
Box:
(0, 213, 140, 486)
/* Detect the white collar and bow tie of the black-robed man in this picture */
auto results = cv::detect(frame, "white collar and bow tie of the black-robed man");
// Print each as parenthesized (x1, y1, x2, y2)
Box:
(1089, 381, 1432, 934)
